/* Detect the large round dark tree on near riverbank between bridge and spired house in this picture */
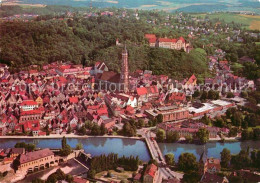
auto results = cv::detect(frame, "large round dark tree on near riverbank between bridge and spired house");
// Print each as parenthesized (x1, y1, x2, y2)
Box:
(178, 153, 198, 172)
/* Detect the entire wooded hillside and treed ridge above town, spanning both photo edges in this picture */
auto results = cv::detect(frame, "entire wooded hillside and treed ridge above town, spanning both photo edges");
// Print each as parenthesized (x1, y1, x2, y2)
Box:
(0, 6, 260, 81)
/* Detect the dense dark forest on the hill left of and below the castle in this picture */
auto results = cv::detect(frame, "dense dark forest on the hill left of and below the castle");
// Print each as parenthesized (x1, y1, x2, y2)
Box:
(0, 12, 207, 78)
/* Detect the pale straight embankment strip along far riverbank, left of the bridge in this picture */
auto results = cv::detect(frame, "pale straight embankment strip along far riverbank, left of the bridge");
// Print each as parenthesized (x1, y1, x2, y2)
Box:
(0, 133, 144, 140)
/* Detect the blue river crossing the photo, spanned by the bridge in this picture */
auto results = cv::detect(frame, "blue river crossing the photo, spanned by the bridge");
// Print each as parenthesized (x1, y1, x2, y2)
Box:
(0, 137, 260, 161)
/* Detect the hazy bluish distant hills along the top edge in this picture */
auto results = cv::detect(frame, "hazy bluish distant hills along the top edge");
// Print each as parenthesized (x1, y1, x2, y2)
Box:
(4, 0, 260, 14)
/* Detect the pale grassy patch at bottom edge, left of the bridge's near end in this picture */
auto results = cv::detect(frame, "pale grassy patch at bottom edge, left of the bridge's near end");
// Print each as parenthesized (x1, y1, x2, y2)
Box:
(96, 170, 133, 182)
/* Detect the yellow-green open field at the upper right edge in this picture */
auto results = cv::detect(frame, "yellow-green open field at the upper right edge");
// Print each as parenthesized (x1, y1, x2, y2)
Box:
(194, 13, 260, 30)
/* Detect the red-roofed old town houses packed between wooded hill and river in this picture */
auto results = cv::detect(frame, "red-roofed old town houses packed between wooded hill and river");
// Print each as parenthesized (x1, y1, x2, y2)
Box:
(0, 45, 253, 138)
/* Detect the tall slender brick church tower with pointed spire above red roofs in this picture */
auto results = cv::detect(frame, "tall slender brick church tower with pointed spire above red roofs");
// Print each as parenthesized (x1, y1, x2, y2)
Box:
(120, 45, 129, 92)
